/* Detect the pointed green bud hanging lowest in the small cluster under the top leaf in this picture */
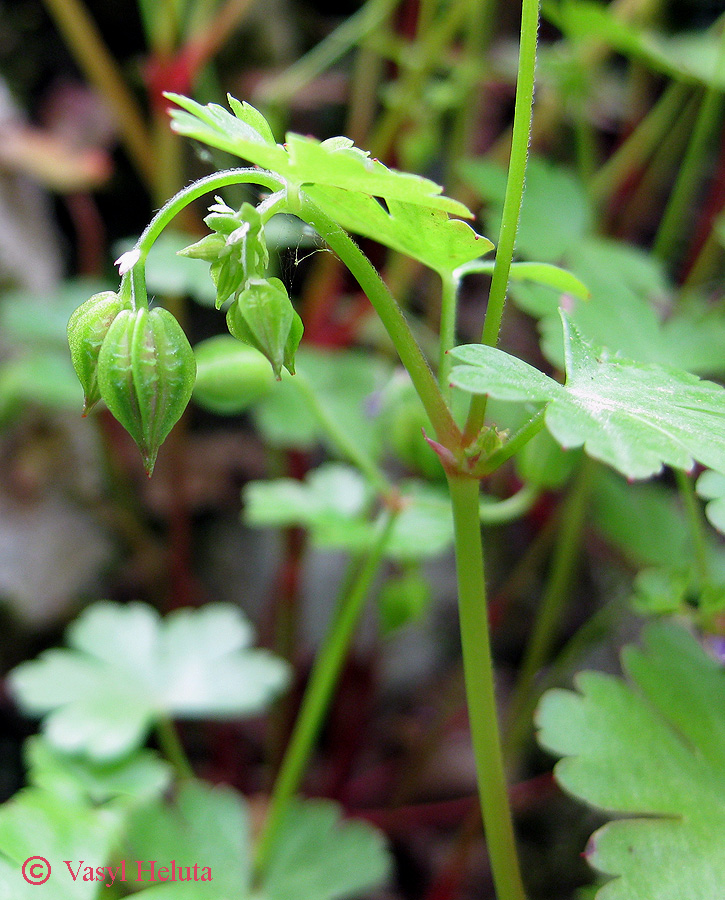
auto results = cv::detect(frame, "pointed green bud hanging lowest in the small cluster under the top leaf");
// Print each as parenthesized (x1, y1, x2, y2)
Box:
(227, 278, 304, 380)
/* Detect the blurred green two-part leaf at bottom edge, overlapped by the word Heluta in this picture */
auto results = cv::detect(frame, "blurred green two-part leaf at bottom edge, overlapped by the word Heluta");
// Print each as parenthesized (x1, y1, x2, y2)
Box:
(126, 782, 390, 900)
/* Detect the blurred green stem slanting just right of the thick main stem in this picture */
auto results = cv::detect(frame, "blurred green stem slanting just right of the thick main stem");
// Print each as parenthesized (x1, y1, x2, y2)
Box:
(506, 459, 594, 750)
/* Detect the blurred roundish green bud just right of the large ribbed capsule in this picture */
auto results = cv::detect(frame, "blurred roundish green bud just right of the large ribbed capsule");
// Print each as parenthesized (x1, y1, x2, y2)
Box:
(194, 334, 274, 416)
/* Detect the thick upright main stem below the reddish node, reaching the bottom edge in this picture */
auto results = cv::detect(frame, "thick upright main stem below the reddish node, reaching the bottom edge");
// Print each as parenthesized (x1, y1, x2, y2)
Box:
(448, 476, 526, 900)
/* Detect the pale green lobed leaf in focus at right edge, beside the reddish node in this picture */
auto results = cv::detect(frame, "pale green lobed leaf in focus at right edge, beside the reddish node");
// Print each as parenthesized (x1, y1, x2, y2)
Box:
(451, 312, 725, 478)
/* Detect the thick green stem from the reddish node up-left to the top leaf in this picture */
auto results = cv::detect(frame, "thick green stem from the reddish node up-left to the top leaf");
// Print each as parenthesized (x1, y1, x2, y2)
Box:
(295, 198, 460, 449)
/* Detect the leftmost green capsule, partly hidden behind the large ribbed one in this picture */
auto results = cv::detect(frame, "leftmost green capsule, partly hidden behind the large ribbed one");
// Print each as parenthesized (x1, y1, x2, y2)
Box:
(68, 291, 131, 416)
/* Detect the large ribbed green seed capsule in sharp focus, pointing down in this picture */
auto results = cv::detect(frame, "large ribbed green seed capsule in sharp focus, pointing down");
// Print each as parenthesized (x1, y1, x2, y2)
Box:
(98, 308, 196, 475)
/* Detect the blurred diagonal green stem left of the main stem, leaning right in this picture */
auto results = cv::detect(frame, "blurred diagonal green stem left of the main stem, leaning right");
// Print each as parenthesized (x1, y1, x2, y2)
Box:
(256, 512, 397, 872)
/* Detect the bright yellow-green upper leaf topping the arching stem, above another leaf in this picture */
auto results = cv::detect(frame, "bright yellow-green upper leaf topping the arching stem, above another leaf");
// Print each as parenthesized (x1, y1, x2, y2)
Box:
(166, 94, 471, 218)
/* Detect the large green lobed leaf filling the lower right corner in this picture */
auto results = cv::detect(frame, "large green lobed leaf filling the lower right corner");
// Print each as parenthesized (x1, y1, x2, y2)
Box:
(537, 624, 725, 900)
